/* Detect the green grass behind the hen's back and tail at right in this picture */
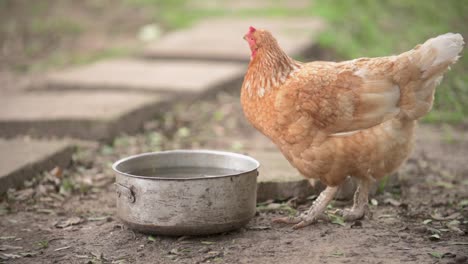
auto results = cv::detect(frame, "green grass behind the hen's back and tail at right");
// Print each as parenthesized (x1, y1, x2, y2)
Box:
(312, 0, 468, 124)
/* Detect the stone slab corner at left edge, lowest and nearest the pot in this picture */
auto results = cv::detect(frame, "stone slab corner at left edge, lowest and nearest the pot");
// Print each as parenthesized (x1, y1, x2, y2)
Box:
(0, 139, 74, 194)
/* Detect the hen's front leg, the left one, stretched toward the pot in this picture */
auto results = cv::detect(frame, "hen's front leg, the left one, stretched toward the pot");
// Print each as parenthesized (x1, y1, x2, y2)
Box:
(273, 187, 338, 229)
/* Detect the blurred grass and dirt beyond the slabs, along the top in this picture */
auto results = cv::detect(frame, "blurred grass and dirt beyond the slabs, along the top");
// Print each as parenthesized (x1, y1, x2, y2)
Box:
(0, 0, 468, 124)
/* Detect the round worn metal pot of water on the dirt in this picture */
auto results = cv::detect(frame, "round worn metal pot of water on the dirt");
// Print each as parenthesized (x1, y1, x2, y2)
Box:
(112, 150, 259, 236)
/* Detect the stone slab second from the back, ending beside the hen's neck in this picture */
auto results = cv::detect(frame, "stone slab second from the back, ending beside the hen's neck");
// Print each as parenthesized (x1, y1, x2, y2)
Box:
(42, 58, 247, 95)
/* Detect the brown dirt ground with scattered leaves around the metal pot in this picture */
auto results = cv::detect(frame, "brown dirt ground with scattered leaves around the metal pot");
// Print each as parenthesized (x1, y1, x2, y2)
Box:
(0, 87, 468, 263)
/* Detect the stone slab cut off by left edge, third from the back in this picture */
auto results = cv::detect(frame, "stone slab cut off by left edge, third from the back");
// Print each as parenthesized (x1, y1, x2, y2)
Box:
(0, 91, 170, 140)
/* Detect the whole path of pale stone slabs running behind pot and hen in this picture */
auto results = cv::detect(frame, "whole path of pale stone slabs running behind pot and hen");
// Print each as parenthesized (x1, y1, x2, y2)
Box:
(0, 18, 323, 198)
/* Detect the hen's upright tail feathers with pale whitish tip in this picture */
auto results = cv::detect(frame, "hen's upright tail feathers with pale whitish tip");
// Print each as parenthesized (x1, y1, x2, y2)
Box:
(400, 33, 465, 120)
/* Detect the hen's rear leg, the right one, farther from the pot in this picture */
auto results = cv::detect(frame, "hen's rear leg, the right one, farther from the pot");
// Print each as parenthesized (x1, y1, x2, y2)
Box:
(341, 179, 370, 221)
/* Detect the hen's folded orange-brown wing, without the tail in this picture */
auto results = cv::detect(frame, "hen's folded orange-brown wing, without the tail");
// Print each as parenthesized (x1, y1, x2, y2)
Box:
(275, 58, 400, 139)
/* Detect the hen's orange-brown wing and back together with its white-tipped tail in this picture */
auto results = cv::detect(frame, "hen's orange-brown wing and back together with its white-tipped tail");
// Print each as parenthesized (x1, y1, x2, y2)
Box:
(275, 33, 464, 141)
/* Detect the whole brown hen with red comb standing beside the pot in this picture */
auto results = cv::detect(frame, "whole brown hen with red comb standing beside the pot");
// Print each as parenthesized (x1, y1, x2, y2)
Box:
(241, 27, 464, 228)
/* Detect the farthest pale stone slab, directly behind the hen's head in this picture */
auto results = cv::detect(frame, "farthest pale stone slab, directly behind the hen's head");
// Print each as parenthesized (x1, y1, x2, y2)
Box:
(142, 18, 324, 62)
